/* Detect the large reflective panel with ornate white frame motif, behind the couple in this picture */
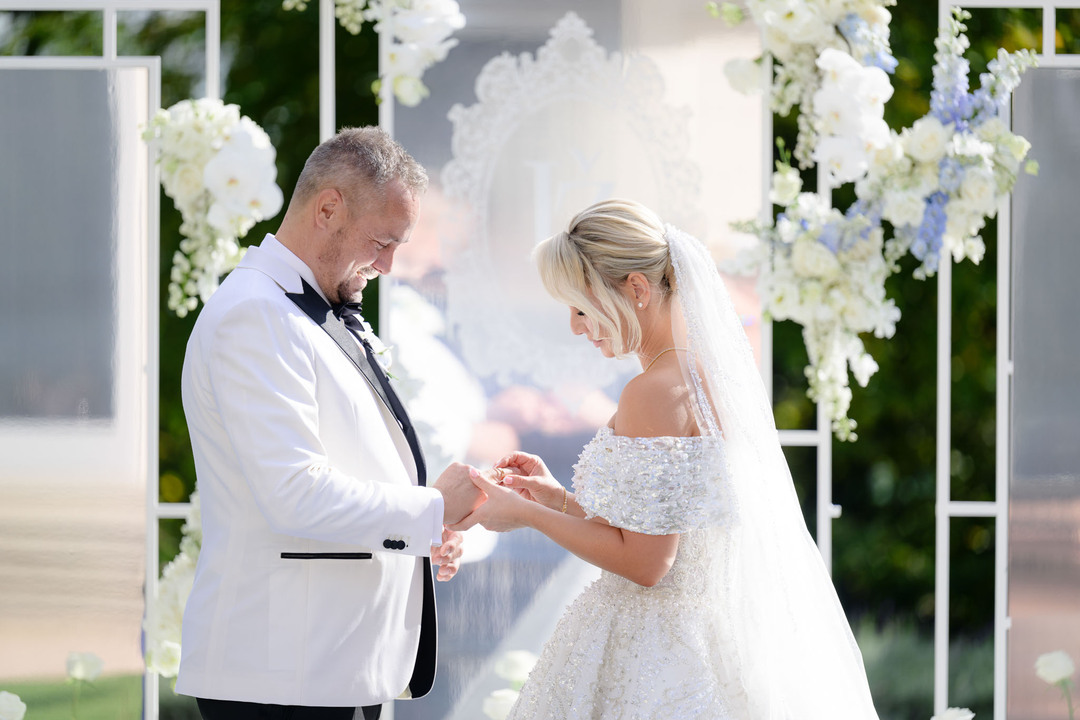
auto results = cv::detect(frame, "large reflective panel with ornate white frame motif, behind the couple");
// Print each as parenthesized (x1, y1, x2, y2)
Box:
(381, 0, 761, 720)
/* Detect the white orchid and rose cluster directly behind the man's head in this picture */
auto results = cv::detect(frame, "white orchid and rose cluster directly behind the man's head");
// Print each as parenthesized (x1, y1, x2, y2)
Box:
(143, 98, 283, 317)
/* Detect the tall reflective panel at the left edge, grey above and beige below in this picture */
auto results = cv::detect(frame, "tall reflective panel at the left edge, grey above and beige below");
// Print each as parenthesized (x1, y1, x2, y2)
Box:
(0, 62, 152, 718)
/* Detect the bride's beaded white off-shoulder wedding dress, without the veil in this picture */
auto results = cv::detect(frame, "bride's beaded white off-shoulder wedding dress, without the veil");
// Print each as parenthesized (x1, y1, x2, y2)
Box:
(509, 427, 746, 720)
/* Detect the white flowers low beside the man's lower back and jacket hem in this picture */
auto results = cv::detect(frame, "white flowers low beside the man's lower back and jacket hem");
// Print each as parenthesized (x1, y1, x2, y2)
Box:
(143, 491, 202, 678)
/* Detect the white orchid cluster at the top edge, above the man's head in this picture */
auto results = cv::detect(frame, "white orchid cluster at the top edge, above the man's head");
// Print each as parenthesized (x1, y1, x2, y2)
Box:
(282, 0, 465, 107)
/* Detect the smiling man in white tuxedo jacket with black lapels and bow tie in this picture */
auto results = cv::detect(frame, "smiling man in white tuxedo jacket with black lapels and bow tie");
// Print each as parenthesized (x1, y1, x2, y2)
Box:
(176, 127, 483, 720)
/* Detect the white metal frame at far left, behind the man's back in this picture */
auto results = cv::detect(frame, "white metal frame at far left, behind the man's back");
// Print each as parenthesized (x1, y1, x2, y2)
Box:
(0, 0, 219, 720)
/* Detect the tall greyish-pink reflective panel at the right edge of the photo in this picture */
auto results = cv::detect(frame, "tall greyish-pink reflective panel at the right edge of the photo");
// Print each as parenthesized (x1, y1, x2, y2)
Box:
(1009, 68, 1080, 718)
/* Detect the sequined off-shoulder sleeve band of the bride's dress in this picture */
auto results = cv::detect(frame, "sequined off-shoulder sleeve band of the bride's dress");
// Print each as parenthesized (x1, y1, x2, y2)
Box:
(573, 431, 731, 535)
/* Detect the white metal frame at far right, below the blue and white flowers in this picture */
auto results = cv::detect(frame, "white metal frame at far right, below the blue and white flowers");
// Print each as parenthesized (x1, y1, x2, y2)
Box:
(934, 0, 1080, 720)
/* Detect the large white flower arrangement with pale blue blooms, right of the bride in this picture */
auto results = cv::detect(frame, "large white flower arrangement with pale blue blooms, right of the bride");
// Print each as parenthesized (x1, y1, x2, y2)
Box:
(729, 8, 1037, 440)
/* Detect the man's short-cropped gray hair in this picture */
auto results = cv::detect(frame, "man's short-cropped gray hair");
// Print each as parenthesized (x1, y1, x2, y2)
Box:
(293, 126, 428, 207)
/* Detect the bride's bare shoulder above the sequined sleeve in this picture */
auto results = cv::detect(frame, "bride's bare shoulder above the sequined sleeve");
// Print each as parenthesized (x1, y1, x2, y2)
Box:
(615, 366, 698, 437)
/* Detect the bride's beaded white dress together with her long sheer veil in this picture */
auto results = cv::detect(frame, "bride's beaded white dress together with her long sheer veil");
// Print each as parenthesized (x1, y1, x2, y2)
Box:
(509, 226, 878, 720)
